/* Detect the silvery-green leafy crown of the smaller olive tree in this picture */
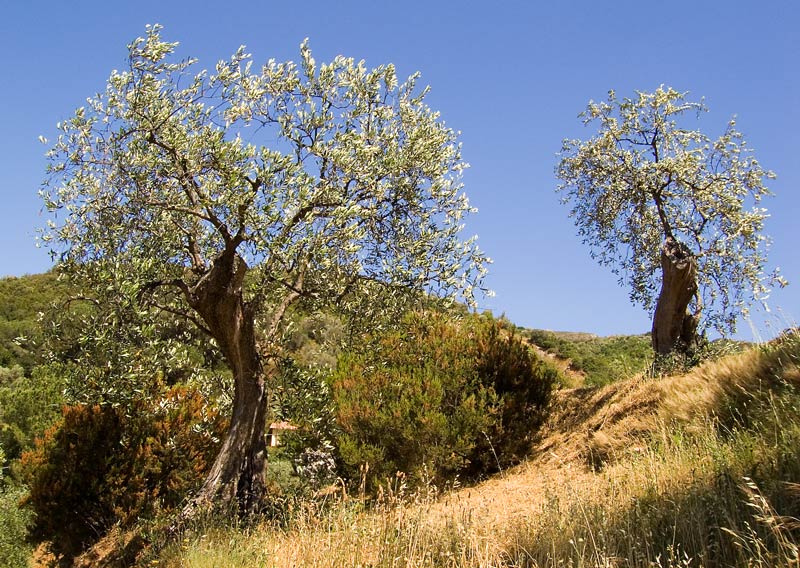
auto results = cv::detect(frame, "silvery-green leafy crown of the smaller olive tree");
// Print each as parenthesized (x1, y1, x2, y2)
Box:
(557, 87, 785, 334)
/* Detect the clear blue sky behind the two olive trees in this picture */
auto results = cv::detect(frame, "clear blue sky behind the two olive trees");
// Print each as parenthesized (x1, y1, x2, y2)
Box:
(0, 0, 800, 338)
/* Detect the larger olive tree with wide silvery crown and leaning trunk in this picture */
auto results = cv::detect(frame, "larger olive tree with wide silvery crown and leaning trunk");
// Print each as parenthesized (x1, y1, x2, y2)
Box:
(41, 26, 488, 515)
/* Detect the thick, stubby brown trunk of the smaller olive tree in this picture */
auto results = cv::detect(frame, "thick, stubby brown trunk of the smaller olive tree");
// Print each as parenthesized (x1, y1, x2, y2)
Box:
(652, 237, 698, 355)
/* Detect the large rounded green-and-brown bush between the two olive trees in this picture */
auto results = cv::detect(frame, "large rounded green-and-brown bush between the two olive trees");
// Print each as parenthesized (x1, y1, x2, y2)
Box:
(331, 313, 556, 485)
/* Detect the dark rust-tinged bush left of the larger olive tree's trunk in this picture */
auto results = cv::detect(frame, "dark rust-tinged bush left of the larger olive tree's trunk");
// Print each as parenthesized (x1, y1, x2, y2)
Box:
(20, 387, 224, 558)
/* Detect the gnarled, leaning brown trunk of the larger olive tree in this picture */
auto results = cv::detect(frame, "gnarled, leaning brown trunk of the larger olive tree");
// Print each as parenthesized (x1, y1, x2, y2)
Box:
(181, 250, 267, 520)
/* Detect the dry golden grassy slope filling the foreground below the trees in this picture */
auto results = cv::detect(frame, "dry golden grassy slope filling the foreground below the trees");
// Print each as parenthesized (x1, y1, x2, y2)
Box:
(148, 335, 800, 568)
